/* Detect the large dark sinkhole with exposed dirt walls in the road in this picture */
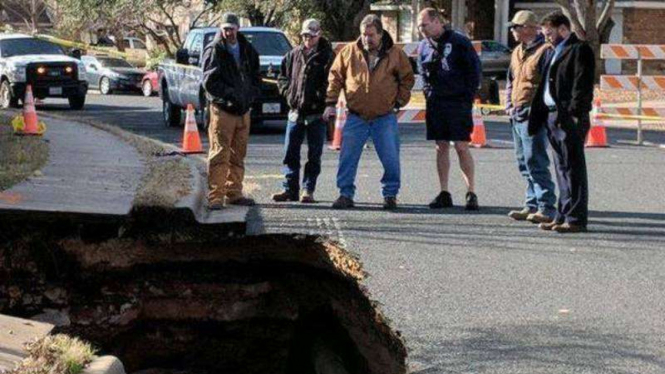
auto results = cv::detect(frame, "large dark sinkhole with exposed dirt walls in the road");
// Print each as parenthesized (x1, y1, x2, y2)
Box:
(0, 219, 406, 374)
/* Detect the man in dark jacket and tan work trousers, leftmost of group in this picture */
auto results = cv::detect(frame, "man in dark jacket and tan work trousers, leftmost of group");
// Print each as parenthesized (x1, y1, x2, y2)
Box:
(203, 13, 261, 210)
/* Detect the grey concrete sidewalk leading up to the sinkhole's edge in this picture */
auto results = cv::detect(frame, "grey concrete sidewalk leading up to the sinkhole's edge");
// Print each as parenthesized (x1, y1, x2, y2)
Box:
(0, 114, 145, 216)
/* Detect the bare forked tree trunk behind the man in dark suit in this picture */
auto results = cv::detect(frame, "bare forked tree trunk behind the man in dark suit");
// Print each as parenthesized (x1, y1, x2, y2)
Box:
(555, 0, 615, 79)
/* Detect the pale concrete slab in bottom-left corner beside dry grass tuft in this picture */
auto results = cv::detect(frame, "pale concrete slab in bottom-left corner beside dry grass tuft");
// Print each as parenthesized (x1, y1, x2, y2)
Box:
(0, 314, 54, 372)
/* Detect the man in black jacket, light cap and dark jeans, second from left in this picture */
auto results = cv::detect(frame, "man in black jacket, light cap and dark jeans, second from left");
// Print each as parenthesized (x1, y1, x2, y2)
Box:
(272, 19, 335, 203)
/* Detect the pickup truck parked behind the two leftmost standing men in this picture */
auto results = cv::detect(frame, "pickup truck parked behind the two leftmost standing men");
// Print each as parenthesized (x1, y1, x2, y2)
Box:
(158, 27, 291, 127)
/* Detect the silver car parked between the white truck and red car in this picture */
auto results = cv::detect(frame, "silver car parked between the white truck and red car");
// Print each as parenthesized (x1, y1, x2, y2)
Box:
(81, 56, 145, 95)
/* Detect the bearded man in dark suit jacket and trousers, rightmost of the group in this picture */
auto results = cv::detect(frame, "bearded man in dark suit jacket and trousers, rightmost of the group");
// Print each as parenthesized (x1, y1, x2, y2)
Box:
(529, 12, 595, 233)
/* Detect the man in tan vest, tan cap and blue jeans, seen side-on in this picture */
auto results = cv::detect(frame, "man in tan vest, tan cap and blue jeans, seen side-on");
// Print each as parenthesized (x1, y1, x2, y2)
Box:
(506, 10, 556, 223)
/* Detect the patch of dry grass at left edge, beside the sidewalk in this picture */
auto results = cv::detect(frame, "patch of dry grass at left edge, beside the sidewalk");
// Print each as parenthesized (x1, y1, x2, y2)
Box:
(0, 111, 49, 191)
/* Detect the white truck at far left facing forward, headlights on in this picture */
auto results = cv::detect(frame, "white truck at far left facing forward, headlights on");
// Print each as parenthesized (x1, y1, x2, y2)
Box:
(0, 34, 88, 110)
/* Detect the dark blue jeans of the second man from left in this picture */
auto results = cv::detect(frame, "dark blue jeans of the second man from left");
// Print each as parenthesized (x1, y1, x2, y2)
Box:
(283, 119, 327, 195)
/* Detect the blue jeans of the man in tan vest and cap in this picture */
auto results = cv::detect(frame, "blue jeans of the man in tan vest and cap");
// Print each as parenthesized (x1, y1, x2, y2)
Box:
(511, 113, 556, 218)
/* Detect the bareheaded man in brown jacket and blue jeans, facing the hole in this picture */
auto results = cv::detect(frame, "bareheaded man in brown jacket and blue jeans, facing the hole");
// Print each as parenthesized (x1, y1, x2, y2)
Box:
(323, 14, 415, 209)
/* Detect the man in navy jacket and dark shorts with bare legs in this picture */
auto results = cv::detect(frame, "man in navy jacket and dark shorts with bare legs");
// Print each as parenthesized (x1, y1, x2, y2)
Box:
(418, 8, 481, 210)
